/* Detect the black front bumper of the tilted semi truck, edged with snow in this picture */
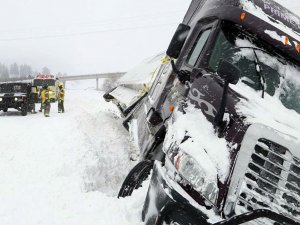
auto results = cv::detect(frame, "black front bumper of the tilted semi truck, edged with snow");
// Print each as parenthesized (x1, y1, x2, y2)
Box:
(142, 162, 300, 225)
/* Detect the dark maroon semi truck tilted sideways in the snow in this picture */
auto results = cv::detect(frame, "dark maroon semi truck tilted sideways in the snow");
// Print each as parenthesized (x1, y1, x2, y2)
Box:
(111, 0, 300, 225)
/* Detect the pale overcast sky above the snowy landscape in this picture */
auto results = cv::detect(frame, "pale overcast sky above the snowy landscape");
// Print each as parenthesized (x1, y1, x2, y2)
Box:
(0, 0, 300, 75)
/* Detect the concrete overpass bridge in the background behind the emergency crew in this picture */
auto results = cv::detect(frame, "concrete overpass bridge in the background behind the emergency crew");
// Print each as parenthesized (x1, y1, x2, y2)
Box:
(0, 72, 125, 90)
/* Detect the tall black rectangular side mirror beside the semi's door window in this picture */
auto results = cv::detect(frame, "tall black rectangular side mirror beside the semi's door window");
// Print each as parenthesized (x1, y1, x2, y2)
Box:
(167, 23, 191, 59)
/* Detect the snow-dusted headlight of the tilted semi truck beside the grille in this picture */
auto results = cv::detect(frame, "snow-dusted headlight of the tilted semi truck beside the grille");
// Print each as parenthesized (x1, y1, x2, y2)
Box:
(172, 151, 218, 204)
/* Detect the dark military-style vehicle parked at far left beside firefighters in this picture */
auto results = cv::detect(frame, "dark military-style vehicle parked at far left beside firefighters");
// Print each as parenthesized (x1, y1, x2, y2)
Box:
(0, 82, 38, 116)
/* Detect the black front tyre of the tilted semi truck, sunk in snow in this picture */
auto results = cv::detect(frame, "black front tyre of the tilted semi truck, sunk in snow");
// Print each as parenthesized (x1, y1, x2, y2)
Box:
(118, 160, 154, 198)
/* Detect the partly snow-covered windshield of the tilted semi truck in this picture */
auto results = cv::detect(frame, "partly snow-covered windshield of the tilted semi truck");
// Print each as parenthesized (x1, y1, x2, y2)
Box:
(209, 21, 300, 114)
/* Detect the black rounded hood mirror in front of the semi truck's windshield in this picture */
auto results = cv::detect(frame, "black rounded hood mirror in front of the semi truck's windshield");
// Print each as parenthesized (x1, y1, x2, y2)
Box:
(218, 60, 241, 84)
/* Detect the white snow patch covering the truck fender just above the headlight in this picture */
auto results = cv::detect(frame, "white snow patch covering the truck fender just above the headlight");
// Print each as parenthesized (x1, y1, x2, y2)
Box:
(164, 105, 230, 182)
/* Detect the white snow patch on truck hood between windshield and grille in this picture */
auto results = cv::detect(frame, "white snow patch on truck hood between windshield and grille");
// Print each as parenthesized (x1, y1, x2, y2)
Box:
(231, 82, 300, 142)
